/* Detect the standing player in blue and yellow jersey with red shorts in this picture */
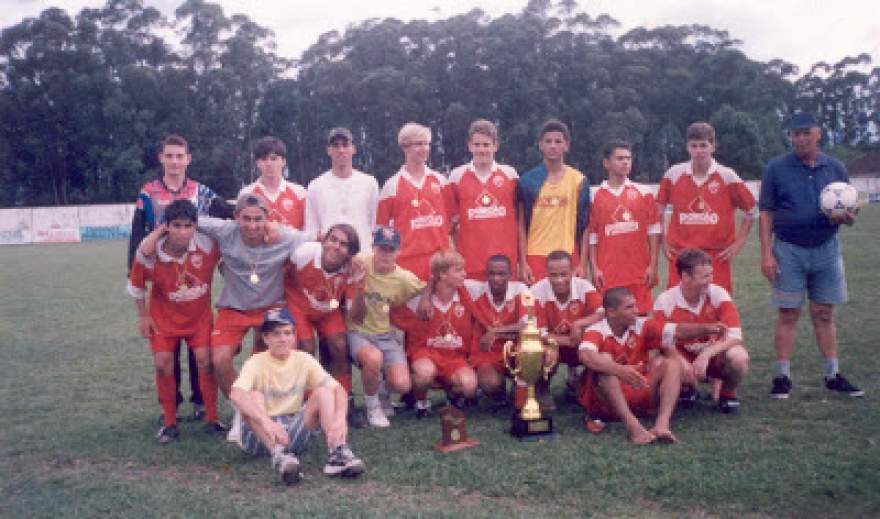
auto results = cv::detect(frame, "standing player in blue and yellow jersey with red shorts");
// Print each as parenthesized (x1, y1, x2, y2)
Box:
(516, 120, 590, 285)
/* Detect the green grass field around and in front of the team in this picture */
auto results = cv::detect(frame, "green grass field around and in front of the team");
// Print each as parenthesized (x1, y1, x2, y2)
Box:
(0, 206, 880, 517)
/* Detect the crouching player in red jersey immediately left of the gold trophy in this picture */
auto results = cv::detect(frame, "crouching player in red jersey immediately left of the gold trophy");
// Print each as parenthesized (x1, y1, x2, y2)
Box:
(464, 254, 526, 403)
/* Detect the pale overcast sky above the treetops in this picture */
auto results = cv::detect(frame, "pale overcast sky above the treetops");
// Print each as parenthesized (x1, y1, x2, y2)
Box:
(0, 0, 880, 73)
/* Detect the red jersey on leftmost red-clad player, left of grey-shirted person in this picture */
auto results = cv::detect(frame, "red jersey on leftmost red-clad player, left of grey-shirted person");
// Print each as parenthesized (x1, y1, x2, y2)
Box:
(128, 233, 220, 337)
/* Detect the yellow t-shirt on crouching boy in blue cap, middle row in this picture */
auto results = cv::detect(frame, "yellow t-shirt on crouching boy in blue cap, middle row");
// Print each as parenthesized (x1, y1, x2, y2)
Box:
(346, 255, 425, 335)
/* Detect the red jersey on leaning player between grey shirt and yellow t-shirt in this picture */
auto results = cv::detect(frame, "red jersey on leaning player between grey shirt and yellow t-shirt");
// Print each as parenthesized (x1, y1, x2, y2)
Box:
(284, 241, 349, 315)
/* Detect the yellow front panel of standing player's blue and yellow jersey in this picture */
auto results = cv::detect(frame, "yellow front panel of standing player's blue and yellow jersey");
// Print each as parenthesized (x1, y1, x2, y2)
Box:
(526, 166, 584, 256)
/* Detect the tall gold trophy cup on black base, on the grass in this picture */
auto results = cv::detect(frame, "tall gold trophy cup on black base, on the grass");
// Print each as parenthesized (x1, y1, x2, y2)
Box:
(504, 290, 556, 439)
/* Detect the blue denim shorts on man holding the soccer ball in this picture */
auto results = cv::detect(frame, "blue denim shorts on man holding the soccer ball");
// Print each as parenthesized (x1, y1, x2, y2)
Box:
(771, 236, 847, 308)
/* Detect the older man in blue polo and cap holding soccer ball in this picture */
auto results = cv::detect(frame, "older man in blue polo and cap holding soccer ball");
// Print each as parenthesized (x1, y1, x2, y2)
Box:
(758, 113, 865, 398)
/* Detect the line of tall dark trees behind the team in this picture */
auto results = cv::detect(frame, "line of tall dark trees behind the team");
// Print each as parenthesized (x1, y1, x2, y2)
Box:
(0, 0, 880, 207)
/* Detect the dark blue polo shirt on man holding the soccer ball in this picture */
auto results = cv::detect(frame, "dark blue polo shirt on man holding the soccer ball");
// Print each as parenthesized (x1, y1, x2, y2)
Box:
(758, 152, 849, 247)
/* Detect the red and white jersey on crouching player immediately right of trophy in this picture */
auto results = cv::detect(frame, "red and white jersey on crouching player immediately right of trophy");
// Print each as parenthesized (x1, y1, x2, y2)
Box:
(532, 277, 602, 335)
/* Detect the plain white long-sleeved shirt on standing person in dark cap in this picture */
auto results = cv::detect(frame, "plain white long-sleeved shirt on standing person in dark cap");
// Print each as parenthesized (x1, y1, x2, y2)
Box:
(304, 169, 379, 251)
